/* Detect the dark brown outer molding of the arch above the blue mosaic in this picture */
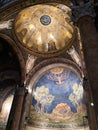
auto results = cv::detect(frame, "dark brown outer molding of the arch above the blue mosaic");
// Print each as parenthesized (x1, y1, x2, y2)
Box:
(26, 58, 82, 86)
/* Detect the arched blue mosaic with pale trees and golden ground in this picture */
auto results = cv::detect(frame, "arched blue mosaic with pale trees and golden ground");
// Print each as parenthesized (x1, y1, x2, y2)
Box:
(28, 67, 89, 130)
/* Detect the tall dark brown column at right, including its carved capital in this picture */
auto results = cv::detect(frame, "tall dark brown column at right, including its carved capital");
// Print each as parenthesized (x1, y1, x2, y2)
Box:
(73, 1, 98, 130)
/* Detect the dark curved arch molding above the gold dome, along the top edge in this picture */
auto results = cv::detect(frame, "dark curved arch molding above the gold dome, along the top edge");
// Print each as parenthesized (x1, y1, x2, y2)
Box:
(0, 0, 72, 21)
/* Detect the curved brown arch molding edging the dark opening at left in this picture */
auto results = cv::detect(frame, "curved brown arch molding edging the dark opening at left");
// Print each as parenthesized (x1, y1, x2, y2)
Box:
(0, 33, 25, 85)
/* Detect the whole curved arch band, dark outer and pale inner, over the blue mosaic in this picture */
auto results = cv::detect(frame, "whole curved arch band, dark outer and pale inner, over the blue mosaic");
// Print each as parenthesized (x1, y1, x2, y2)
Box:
(26, 58, 82, 92)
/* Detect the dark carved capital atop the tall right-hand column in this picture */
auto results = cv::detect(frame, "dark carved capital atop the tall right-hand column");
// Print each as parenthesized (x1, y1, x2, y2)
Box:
(72, 0, 95, 22)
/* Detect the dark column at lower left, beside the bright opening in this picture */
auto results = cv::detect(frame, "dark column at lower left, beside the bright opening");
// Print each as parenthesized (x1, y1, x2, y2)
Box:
(6, 87, 25, 130)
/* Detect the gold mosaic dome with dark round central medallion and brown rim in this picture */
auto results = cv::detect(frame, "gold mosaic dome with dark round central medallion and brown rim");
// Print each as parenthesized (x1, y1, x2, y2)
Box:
(14, 4, 74, 57)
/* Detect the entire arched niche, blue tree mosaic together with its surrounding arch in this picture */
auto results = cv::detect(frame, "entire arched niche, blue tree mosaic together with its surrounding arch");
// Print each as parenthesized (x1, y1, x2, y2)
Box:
(22, 58, 88, 130)
